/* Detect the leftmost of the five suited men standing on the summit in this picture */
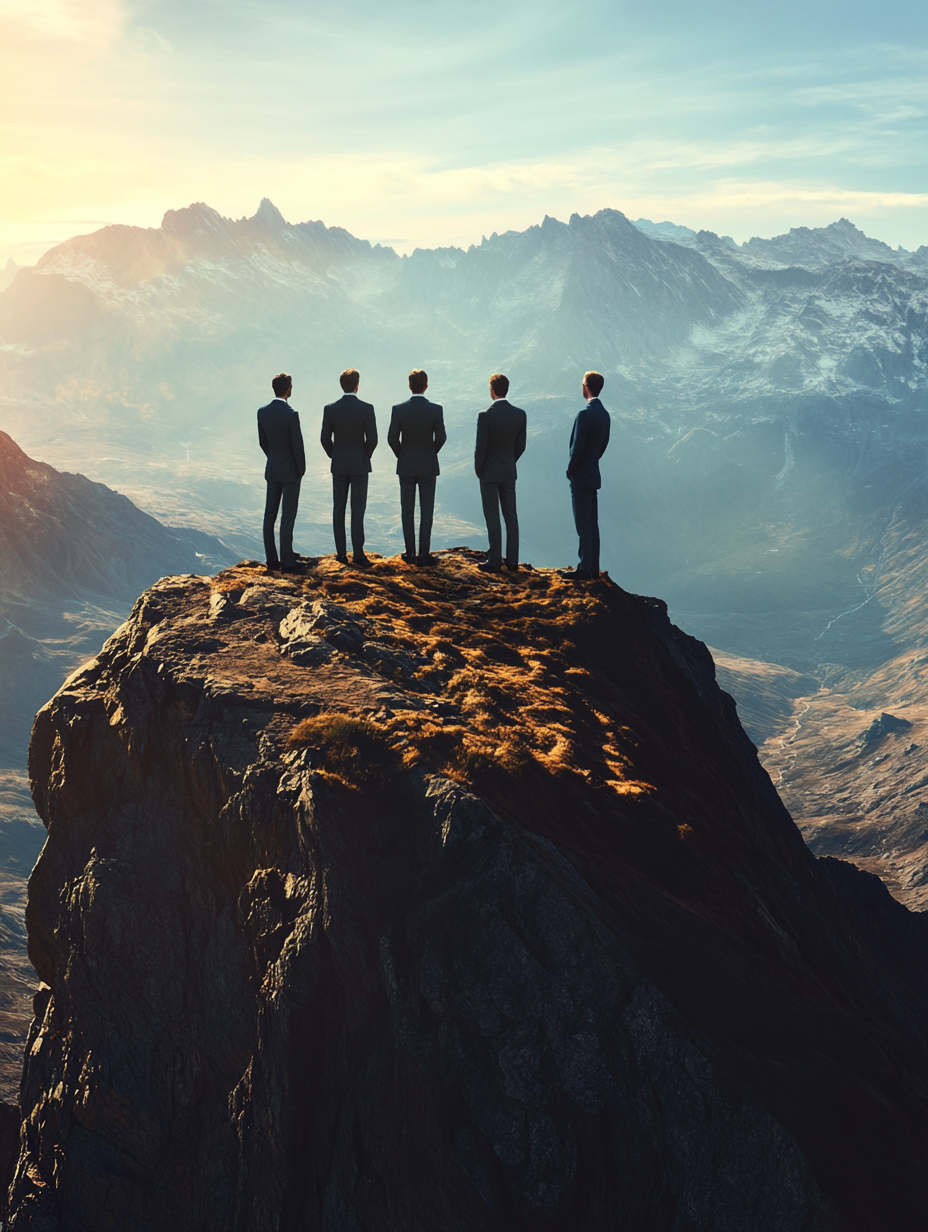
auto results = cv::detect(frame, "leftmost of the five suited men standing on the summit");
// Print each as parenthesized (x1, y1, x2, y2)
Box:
(258, 372, 306, 573)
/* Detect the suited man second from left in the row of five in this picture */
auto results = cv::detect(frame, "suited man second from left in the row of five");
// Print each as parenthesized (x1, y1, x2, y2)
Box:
(320, 368, 377, 569)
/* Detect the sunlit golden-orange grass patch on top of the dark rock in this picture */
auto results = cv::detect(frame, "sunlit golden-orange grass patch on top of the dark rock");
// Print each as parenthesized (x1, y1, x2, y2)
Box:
(271, 549, 653, 796)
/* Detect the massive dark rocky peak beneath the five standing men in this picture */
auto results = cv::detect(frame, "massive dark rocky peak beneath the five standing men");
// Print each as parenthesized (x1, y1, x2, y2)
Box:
(10, 549, 928, 1232)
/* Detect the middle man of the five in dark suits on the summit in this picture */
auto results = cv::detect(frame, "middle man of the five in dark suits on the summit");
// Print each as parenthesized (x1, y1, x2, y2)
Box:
(387, 368, 446, 565)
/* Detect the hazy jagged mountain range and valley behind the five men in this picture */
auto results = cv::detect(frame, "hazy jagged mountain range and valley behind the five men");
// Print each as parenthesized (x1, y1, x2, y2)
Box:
(0, 200, 928, 897)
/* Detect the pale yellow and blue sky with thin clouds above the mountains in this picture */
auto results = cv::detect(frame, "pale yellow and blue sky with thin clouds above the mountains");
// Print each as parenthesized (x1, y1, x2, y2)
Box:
(0, 0, 928, 265)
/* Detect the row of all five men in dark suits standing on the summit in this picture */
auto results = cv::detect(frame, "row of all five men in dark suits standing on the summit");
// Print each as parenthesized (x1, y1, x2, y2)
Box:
(258, 368, 610, 582)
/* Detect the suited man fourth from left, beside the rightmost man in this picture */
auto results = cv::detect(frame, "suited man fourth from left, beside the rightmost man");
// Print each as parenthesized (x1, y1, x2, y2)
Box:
(473, 372, 526, 573)
